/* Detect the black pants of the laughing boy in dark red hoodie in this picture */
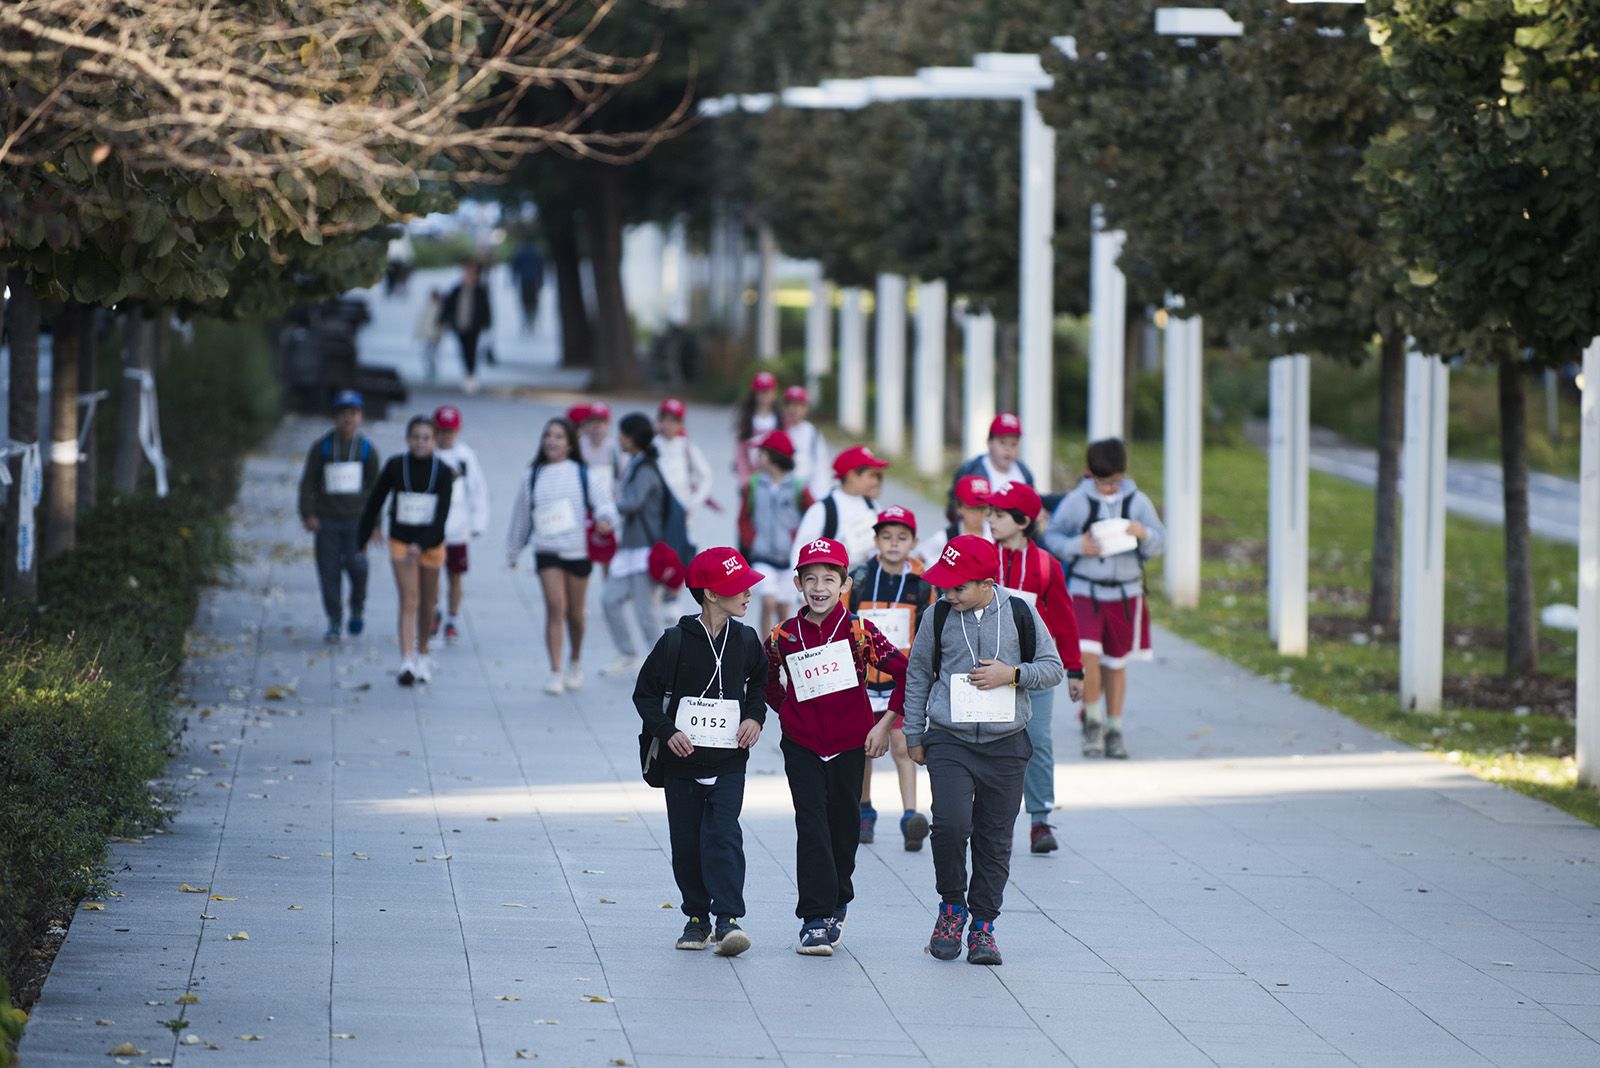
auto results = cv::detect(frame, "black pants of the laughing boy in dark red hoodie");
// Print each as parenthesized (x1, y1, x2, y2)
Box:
(781, 739, 867, 919)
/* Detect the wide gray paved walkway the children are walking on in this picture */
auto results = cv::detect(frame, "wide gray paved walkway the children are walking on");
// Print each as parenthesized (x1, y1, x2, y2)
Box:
(22, 382, 1600, 1068)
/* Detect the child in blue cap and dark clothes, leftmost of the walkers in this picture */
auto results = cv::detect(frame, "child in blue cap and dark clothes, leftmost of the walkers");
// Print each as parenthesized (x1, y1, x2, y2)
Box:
(299, 390, 378, 643)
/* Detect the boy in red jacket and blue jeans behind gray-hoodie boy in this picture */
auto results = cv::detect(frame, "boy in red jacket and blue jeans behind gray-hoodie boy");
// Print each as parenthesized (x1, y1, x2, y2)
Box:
(989, 483, 1083, 852)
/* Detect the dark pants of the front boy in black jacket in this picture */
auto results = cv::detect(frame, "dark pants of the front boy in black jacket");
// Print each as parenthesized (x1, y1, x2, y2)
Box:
(666, 771, 744, 919)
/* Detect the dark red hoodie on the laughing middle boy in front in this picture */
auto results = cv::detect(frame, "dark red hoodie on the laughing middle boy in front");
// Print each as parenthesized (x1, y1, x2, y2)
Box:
(766, 601, 906, 756)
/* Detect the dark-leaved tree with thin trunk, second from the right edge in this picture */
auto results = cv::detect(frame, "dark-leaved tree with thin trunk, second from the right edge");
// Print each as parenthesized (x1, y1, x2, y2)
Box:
(1043, 0, 1406, 622)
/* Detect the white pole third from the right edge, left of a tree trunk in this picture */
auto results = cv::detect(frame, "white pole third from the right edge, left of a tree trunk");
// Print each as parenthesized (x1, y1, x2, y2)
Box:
(1267, 355, 1310, 657)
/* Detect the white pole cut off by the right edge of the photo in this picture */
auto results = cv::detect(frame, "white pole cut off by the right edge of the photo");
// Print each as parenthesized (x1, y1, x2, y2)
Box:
(1578, 337, 1600, 787)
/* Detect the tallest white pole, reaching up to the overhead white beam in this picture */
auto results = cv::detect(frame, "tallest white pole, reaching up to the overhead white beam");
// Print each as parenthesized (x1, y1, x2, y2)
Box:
(1017, 94, 1056, 492)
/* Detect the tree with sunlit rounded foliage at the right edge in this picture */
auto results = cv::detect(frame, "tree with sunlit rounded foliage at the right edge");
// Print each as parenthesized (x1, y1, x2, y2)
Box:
(1363, 0, 1600, 676)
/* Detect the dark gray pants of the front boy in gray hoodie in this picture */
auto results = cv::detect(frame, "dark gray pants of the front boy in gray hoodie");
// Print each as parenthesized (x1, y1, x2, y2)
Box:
(926, 734, 1029, 923)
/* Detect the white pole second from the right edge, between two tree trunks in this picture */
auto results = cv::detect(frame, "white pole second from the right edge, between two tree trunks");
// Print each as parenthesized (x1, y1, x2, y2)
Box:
(1400, 352, 1450, 711)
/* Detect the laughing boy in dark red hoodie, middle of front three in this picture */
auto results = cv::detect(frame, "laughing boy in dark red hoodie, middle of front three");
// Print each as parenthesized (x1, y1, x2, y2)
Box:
(766, 537, 906, 956)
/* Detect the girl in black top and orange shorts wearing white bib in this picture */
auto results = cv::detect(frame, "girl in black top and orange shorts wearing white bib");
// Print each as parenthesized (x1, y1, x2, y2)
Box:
(357, 416, 454, 686)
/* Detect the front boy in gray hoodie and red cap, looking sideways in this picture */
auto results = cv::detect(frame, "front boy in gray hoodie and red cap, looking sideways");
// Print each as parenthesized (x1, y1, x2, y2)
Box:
(906, 534, 1066, 964)
